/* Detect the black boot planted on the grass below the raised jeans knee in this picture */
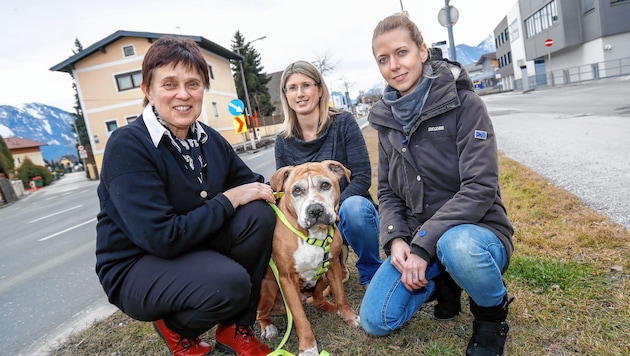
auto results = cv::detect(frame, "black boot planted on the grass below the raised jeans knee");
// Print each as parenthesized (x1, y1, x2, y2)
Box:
(466, 294, 514, 356)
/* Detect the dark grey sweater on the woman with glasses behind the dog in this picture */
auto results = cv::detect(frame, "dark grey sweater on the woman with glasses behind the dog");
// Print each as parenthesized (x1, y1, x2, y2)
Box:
(275, 112, 372, 204)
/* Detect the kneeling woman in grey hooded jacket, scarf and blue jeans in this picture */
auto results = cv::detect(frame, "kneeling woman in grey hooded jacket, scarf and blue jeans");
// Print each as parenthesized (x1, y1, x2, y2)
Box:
(361, 13, 513, 355)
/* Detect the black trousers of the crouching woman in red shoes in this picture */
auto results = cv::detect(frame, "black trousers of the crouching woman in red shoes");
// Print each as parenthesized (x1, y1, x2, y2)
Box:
(118, 201, 276, 339)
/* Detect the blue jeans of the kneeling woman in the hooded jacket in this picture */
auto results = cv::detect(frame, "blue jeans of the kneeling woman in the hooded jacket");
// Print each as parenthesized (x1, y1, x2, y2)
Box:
(360, 224, 507, 336)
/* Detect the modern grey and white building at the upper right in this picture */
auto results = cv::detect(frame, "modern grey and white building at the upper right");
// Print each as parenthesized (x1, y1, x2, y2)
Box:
(494, 0, 630, 90)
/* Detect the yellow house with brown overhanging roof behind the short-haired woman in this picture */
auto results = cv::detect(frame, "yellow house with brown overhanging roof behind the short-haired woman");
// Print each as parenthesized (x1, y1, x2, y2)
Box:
(50, 31, 243, 171)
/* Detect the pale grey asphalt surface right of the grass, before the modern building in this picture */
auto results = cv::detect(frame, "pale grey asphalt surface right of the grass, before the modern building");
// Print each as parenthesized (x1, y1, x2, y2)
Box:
(483, 76, 630, 229)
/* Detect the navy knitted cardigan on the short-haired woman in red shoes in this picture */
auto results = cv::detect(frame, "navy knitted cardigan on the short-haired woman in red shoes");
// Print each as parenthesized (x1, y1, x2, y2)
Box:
(96, 105, 263, 301)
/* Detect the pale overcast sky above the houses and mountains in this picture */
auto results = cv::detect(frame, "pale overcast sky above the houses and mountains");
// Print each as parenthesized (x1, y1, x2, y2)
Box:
(0, 0, 516, 112)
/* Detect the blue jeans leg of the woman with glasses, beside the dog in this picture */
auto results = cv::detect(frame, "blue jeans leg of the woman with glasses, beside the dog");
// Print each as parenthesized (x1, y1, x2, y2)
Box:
(337, 195, 383, 286)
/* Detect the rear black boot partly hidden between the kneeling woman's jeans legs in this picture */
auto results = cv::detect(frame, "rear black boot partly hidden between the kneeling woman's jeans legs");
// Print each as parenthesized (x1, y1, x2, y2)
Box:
(428, 273, 462, 320)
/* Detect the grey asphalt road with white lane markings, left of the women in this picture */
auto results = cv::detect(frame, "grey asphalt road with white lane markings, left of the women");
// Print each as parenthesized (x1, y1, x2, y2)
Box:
(0, 173, 113, 355)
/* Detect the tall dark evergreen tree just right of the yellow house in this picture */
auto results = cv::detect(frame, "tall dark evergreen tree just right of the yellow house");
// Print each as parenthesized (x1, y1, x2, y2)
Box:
(232, 31, 275, 116)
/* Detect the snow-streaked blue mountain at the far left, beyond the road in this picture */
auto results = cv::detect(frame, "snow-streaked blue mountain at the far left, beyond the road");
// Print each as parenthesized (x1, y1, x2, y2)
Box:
(0, 103, 77, 162)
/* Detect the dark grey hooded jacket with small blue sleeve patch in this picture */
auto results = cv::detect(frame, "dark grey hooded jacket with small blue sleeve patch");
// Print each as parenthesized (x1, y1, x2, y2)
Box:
(368, 60, 514, 269)
